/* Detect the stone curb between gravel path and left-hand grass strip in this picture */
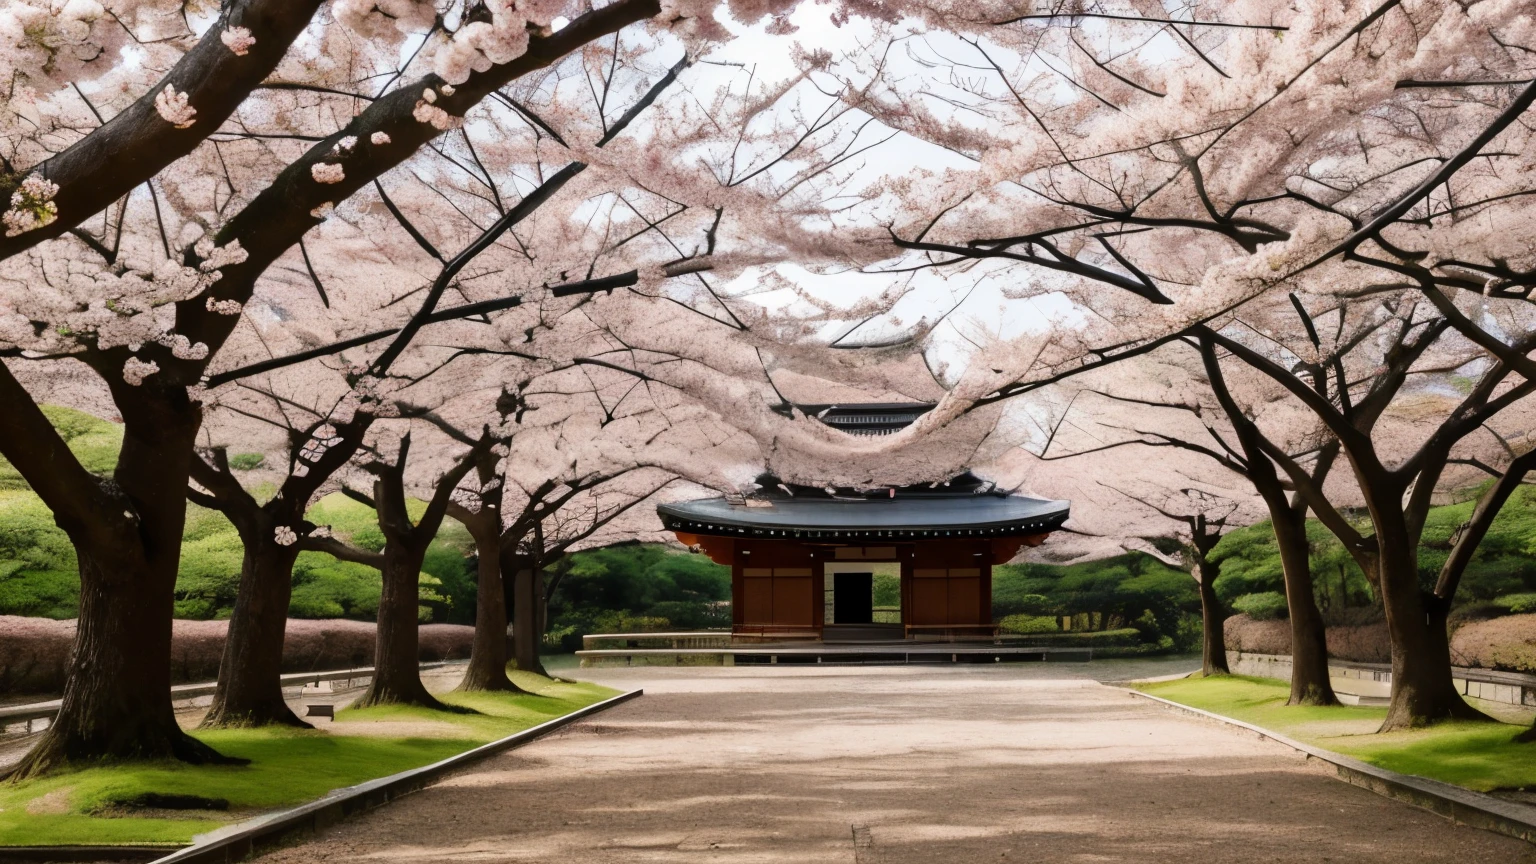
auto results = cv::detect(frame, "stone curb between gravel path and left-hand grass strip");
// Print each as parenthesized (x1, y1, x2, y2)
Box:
(142, 690, 645, 864)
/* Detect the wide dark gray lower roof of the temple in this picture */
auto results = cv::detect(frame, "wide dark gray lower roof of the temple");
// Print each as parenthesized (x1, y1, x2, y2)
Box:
(656, 495, 1071, 540)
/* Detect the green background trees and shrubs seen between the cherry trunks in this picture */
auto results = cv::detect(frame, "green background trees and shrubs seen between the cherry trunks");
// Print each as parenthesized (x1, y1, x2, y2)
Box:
(9, 407, 1536, 652)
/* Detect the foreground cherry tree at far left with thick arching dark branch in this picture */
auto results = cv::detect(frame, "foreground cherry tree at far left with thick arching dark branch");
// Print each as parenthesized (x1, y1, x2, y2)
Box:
(0, 0, 866, 775)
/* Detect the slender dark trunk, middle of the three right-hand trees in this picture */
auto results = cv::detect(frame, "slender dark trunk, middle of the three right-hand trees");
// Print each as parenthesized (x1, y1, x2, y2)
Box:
(1270, 506, 1338, 706)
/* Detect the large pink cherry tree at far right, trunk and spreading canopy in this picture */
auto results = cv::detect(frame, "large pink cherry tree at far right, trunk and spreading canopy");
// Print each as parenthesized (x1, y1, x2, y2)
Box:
(847, 0, 1536, 729)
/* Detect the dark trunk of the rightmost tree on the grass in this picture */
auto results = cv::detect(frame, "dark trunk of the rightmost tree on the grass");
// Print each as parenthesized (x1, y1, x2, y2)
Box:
(1376, 535, 1490, 732)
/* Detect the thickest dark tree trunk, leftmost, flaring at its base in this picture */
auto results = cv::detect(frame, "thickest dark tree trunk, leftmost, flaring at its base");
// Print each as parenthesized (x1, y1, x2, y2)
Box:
(9, 405, 240, 779)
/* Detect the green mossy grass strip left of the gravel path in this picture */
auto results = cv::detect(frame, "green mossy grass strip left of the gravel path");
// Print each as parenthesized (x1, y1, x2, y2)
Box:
(0, 672, 616, 846)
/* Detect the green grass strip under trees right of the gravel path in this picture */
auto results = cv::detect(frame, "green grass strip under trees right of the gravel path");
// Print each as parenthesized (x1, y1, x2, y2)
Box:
(1137, 675, 1536, 792)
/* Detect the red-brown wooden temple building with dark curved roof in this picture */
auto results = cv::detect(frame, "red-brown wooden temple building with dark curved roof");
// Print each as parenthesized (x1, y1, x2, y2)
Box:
(656, 403, 1069, 641)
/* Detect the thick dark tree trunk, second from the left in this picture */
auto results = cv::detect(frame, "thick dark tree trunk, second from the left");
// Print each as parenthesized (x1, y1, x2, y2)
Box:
(203, 531, 310, 729)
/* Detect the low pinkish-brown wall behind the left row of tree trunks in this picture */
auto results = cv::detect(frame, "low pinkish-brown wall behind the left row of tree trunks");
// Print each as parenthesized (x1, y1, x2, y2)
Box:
(0, 615, 497, 695)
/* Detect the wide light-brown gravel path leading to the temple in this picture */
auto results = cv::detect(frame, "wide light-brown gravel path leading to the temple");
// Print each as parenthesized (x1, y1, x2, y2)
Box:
(245, 663, 1536, 864)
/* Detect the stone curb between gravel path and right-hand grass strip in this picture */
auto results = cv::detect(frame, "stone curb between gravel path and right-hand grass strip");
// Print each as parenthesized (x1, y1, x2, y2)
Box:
(1120, 687, 1536, 842)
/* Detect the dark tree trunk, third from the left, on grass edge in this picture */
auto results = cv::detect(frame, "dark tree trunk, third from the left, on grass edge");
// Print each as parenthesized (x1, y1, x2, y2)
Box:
(356, 543, 445, 710)
